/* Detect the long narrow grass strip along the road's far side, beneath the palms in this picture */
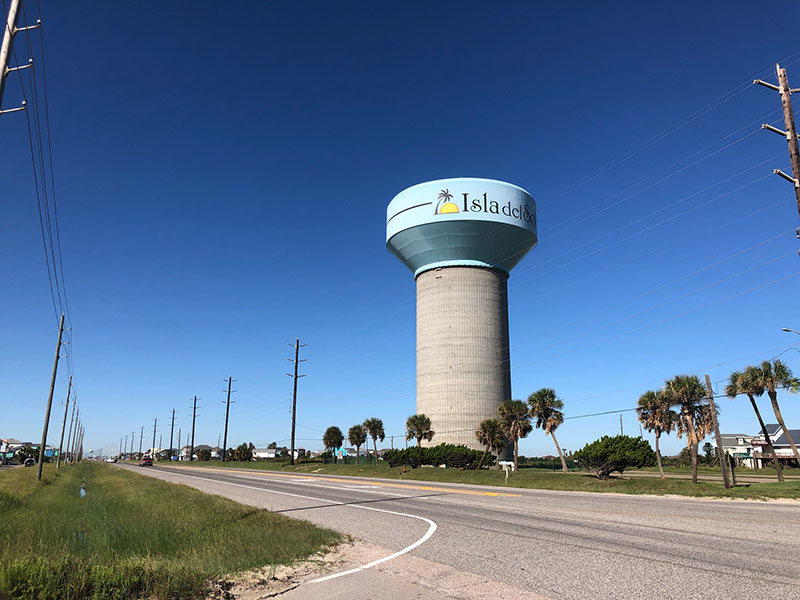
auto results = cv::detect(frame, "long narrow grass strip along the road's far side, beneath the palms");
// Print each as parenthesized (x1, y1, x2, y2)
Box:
(172, 461, 800, 500)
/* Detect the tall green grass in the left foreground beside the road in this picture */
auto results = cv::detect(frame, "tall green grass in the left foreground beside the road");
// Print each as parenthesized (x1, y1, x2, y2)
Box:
(0, 463, 340, 600)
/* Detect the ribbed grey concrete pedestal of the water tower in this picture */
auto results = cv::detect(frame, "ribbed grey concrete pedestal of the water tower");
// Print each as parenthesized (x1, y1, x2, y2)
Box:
(417, 267, 511, 450)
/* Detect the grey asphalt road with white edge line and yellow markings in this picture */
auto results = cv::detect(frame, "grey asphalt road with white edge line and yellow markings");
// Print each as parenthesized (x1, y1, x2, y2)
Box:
(122, 467, 800, 600)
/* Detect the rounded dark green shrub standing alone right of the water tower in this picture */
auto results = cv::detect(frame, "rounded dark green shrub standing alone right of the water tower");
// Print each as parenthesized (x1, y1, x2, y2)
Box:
(573, 435, 656, 479)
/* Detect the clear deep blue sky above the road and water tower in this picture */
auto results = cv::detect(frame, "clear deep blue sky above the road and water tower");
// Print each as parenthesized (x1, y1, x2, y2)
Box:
(0, 0, 800, 455)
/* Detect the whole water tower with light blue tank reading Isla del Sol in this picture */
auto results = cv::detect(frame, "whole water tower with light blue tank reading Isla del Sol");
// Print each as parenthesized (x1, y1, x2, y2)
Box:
(386, 177, 537, 449)
